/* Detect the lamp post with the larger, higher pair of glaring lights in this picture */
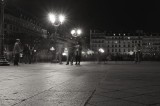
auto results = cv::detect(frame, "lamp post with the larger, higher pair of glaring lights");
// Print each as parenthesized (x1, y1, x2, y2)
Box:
(48, 13, 65, 62)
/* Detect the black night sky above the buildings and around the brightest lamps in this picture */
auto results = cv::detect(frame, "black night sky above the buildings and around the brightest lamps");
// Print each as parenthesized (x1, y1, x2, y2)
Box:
(8, 0, 160, 32)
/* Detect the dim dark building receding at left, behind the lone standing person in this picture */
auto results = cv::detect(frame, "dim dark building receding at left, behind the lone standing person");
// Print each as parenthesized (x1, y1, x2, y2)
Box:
(4, 7, 47, 51)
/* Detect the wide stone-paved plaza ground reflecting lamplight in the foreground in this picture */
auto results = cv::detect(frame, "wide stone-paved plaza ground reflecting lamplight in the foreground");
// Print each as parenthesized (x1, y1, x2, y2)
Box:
(0, 62, 160, 106)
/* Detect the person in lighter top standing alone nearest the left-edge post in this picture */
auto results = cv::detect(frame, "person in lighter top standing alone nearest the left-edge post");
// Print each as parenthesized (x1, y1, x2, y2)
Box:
(13, 39, 21, 66)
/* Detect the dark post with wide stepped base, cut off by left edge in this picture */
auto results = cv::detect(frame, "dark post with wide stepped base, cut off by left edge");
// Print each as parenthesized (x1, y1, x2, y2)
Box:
(0, 0, 9, 66)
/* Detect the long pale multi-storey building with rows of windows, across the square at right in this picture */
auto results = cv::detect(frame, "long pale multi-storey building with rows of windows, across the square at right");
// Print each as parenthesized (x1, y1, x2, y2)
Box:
(90, 31, 160, 60)
